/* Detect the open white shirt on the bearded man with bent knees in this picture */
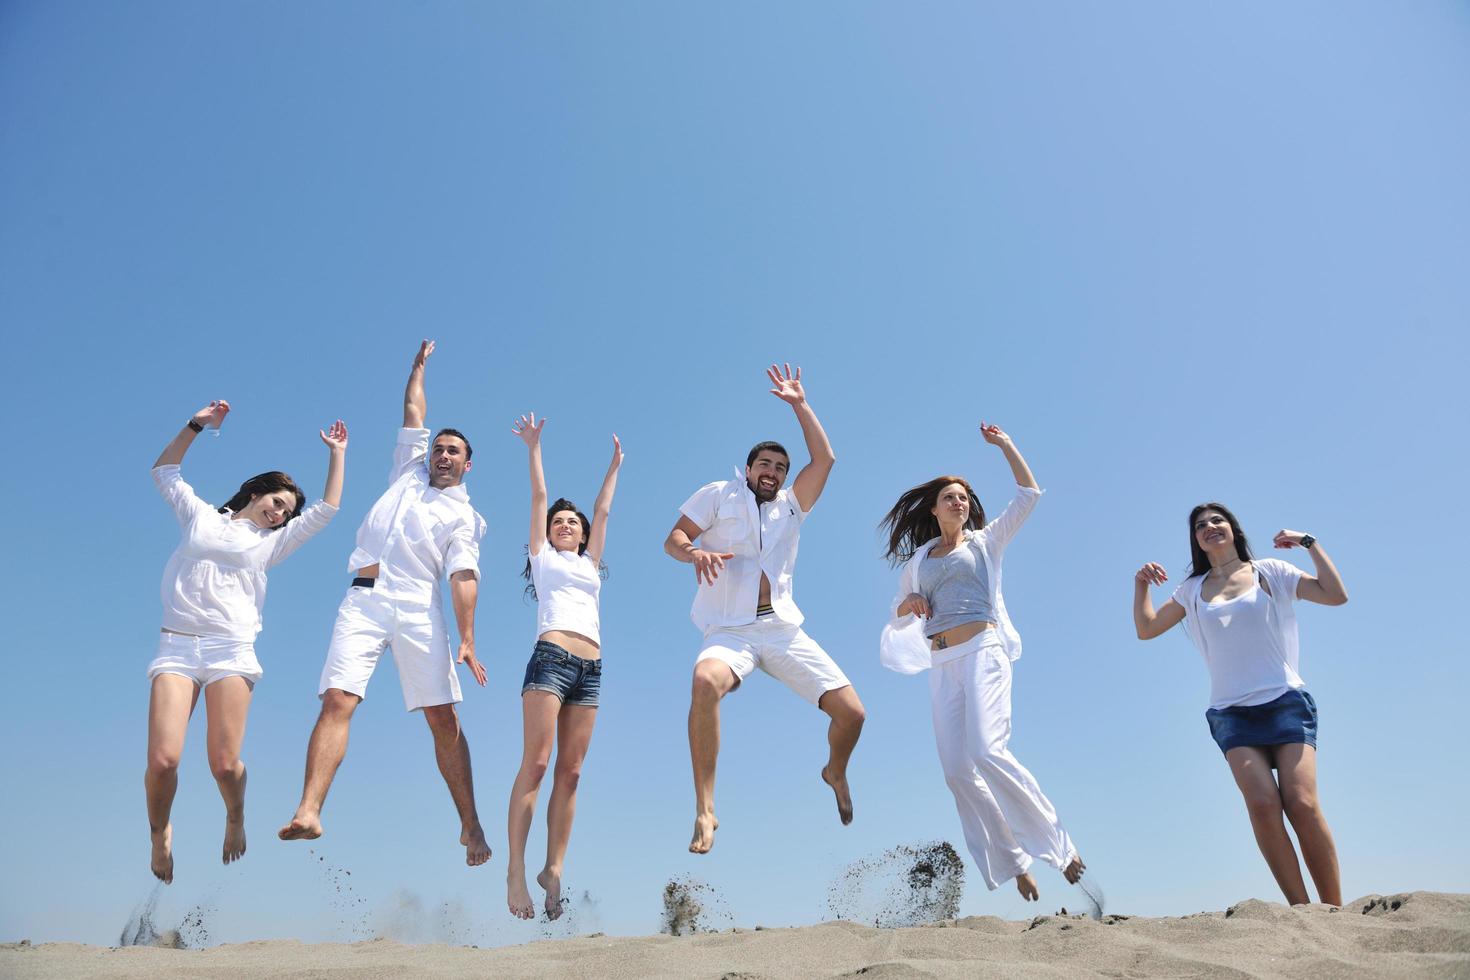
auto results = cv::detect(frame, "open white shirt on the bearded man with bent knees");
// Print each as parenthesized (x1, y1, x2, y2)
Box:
(679, 467, 807, 633)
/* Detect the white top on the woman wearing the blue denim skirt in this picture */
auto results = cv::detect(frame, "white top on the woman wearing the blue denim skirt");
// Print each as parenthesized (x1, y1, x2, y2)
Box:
(1173, 558, 1305, 708)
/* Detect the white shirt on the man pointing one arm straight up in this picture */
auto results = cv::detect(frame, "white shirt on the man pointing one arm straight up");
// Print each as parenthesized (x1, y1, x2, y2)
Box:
(347, 429, 485, 602)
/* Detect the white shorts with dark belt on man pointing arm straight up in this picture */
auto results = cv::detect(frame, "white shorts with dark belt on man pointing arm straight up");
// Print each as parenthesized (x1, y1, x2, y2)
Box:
(316, 585, 463, 711)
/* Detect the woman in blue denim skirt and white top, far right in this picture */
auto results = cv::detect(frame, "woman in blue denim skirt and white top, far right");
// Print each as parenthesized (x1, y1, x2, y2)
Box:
(1133, 502, 1348, 905)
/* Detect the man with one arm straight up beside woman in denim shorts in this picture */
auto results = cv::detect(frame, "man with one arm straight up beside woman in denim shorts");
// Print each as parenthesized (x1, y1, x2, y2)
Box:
(279, 341, 490, 865)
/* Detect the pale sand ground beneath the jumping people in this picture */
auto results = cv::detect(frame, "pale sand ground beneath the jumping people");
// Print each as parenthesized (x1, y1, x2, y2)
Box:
(0, 892, 1470, 980)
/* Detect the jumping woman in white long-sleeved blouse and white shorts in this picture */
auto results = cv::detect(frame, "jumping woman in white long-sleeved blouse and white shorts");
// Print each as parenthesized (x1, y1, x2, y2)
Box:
(143, 401, 347, 883)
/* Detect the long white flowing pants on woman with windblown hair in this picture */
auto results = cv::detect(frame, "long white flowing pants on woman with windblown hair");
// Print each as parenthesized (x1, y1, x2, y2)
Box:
(929, 629, 1078, 890)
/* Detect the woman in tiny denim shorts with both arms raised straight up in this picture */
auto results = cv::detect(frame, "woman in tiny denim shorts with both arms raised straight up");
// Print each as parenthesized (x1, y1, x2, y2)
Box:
(506, 414, 623, 918)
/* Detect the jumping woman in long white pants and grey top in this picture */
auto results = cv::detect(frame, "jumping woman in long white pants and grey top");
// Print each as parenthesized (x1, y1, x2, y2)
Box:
(881, 423, 1097, 901)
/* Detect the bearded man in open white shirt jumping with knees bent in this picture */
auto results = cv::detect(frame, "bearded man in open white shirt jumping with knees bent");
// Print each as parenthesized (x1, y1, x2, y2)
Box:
(663, 364, 866, 854)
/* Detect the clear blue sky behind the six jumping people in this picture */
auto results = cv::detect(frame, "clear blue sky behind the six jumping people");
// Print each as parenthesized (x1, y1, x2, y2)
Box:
(0, 0, 1470, 945)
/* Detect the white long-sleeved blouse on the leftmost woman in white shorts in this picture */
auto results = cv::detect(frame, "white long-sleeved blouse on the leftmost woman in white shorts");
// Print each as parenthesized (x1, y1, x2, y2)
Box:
(153, 466, 337, 641)
